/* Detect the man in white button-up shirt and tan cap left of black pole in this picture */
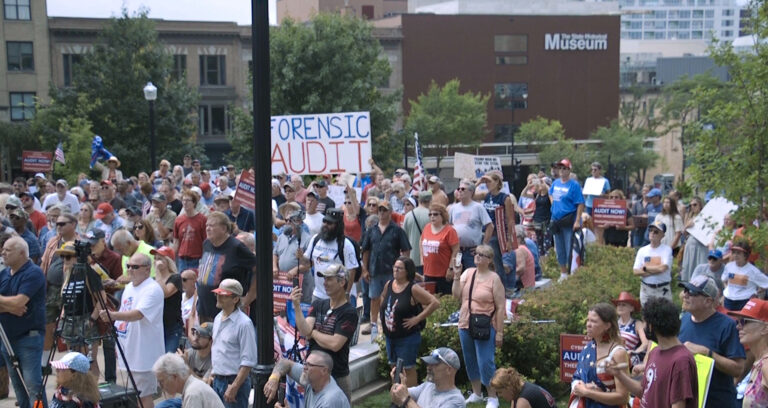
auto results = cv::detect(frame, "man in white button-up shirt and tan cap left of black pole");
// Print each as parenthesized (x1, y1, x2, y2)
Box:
(211, 279, 257, 408)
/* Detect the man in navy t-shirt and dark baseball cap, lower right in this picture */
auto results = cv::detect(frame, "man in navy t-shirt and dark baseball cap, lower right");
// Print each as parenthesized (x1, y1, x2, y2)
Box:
(678, 275, 746, 407)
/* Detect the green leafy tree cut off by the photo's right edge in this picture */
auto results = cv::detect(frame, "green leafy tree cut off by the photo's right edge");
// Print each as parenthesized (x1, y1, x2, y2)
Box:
(689, 1, 768, 266)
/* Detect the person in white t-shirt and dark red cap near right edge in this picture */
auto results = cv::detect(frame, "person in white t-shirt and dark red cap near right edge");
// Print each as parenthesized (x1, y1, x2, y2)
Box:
(720, 239, 768, 311)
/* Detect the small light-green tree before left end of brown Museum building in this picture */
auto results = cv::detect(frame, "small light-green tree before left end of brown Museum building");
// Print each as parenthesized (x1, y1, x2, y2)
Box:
(405, 79, 490, 170)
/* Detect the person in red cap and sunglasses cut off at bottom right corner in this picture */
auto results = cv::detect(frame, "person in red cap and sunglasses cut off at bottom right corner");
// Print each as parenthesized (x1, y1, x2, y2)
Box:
(728, 299, 768, 408)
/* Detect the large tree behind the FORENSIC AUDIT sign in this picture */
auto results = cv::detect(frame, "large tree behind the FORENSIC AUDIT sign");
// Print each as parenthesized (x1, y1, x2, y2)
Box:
(227, 13, 400, 169)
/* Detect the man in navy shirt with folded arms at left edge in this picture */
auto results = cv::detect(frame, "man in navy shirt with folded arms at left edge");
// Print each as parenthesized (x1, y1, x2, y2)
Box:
(0, 237, 48, 408)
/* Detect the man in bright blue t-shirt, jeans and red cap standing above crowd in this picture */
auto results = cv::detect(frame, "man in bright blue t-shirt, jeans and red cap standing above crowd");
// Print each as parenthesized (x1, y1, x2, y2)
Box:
(549, 159, 584, 281)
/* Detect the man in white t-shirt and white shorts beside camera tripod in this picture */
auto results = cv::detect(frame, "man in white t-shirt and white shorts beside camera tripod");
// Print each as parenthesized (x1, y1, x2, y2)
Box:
(99, 252, 165, 408)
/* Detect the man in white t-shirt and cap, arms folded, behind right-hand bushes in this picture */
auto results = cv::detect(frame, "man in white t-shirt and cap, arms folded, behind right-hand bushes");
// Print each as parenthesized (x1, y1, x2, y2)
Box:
(633, 221, 672, 304)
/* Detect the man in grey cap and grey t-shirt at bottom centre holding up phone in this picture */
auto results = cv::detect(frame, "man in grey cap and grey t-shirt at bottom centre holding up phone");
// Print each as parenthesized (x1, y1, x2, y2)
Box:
(389, 347, 465, 408)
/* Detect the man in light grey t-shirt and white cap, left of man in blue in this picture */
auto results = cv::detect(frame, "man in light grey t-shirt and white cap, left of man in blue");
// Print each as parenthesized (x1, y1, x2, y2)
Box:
(449, 180, 493, 269)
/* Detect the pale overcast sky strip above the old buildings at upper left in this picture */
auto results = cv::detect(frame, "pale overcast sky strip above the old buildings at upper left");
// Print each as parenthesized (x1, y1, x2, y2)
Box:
(47, 0, 277, 25)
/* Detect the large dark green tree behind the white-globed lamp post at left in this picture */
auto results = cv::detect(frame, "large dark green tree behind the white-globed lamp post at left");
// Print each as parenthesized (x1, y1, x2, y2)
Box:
(44, 9, 203, 174)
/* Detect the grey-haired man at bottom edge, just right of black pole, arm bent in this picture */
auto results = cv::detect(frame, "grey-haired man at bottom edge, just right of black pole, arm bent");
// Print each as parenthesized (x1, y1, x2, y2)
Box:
(264, 350, 349, 408)
